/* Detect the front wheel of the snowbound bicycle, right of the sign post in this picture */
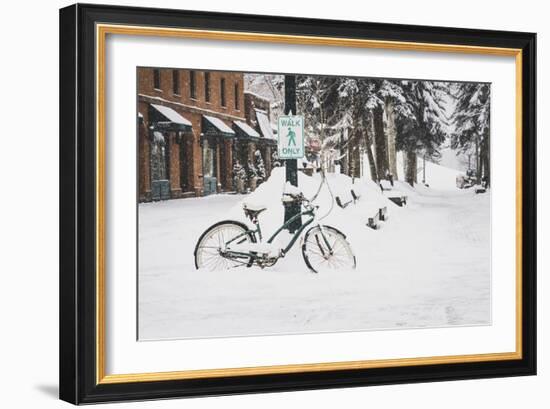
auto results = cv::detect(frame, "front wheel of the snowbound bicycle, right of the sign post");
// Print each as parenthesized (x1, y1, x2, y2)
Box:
(302, 226, 356, 273)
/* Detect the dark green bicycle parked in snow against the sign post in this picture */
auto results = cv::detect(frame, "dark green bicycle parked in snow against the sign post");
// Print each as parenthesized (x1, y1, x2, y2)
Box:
(194, 178, 356, 273)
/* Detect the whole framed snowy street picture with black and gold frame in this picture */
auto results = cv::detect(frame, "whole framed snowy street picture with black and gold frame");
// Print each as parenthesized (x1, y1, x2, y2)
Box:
(60, 5, 536, 404)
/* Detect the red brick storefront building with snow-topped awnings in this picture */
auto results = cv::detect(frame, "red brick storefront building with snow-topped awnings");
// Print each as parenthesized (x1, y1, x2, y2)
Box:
(137, 68, 276, 201)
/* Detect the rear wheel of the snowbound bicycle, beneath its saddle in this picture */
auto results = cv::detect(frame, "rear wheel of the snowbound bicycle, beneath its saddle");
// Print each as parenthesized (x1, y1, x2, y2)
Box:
(194, 220, 256, 271)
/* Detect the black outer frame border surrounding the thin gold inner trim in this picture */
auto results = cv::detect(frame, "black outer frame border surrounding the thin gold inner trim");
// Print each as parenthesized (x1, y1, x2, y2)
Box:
(59, 4, 537, 404)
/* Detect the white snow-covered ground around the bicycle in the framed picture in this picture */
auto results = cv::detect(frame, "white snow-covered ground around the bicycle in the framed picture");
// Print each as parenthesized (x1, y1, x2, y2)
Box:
(138, 164, 491, 340)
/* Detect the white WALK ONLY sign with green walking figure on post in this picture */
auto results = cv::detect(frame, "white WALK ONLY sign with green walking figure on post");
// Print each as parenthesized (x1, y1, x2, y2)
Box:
(277, 113, 305, 159)
